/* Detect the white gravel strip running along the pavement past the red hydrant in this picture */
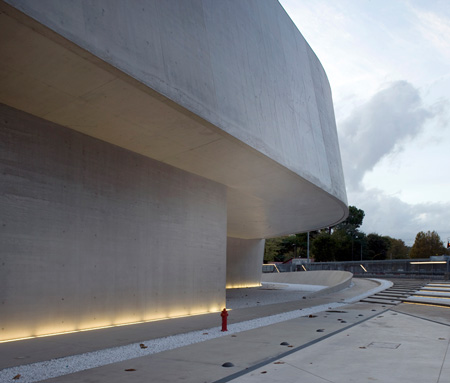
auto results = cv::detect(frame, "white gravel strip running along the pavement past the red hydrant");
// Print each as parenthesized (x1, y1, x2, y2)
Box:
(0, 280, 392, 383)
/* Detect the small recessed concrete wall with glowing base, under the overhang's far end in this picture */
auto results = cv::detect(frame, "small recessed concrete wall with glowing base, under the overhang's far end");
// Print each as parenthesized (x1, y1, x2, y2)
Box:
(227, 237, 265, 288)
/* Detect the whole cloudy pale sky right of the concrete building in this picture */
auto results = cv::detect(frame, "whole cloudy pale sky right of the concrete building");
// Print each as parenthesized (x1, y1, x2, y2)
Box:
(280, 0, 450, 246)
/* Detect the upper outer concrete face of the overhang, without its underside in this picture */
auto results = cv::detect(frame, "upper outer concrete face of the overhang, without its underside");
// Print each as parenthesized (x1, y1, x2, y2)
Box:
(7, 0, 347, 206)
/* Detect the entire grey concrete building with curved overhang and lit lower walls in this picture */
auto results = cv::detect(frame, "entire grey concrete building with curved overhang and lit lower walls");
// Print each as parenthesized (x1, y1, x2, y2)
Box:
(0, 0, 348, 339)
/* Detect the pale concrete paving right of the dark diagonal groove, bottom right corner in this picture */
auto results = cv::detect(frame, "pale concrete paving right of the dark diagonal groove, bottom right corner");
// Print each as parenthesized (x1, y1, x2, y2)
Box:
(230, 309, 450, 383)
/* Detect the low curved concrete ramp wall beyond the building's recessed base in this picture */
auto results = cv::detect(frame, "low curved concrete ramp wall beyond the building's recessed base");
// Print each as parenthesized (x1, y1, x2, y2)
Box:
(261, 270, 353, 295)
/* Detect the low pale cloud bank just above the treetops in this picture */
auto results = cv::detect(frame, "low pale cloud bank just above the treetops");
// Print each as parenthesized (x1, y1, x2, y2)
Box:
(349, 189, 450, 246)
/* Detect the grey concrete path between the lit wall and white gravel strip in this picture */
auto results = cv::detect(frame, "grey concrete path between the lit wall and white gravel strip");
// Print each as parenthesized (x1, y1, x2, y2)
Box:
(0, 279, 380, 369)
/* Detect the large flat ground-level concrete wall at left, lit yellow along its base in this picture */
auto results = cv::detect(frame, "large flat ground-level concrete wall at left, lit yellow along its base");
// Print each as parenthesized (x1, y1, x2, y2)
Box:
(0, 104, 226, 339)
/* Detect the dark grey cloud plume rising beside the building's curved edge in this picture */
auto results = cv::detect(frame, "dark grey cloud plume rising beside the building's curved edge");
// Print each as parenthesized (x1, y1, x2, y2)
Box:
(338, 81, 434, 189)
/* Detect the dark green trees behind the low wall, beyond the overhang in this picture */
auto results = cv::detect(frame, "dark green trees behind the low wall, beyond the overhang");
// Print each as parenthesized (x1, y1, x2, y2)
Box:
(264, 206, 450, 262)
